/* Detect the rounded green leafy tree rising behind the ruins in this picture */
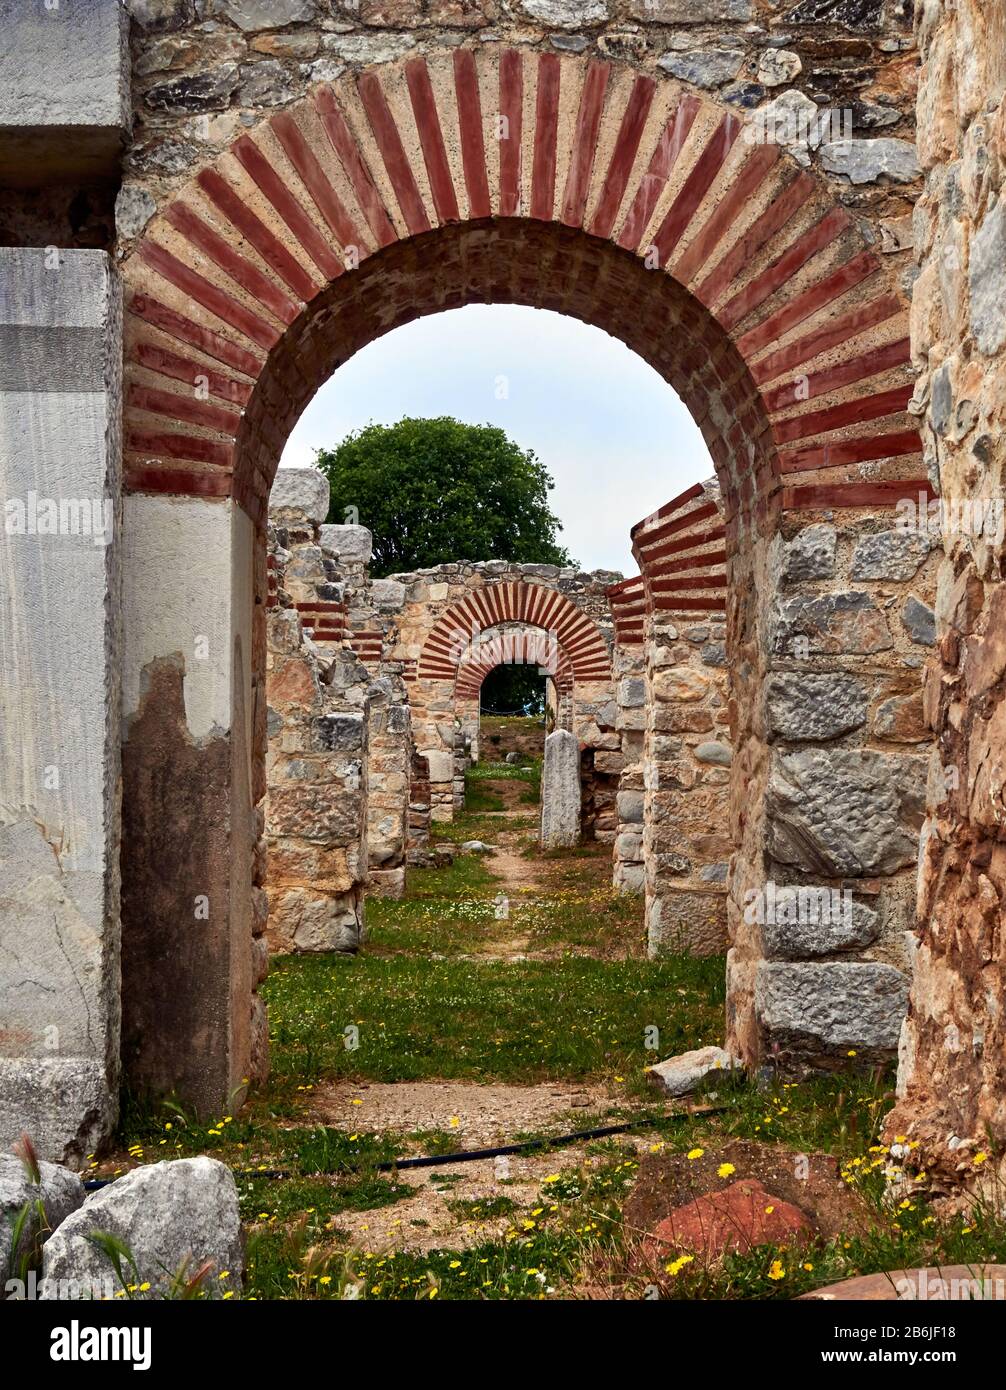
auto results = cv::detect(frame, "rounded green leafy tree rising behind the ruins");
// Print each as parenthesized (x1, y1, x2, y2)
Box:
(318, 416, 574, 575)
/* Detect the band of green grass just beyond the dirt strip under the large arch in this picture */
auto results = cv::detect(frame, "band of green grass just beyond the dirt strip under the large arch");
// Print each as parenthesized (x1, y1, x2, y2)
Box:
(264, 955, 724, 1090)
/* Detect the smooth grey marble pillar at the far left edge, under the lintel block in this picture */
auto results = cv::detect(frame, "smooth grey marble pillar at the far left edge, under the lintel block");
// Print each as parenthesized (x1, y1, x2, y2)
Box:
(0, 247, 121, 1162)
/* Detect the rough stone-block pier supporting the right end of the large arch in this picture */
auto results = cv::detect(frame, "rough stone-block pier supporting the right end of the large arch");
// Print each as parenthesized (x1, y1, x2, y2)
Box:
(727, 509, 937, 1073)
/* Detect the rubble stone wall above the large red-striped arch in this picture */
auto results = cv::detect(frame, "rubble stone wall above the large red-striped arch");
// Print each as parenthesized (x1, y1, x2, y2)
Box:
(108, 0, 917, 276)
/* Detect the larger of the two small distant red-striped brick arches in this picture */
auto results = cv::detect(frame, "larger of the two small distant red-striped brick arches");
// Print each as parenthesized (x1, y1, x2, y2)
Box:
(415, 580, 611, 687)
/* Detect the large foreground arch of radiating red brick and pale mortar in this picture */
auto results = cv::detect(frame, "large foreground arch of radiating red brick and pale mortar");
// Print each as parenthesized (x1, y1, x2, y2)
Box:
(125, 44, 927, 530)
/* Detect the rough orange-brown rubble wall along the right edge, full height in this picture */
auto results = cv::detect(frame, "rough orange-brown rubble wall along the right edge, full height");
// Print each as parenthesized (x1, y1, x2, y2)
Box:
(889, 0, 1006, 1193)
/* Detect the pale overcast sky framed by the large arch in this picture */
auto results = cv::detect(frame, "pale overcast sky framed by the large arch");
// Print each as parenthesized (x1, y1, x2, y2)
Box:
(282, 304, 713, 574)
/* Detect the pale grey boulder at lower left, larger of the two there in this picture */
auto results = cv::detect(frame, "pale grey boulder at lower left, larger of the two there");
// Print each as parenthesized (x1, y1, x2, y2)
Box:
(42, 1158, 245, 1298)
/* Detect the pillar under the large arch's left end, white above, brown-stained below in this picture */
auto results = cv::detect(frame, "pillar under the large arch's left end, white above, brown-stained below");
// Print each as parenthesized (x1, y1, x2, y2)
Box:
(122, 495, 259, 1116)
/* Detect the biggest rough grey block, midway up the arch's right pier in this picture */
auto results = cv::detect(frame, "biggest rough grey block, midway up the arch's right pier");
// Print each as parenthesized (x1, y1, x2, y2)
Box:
(766, 748, 925, 877)
